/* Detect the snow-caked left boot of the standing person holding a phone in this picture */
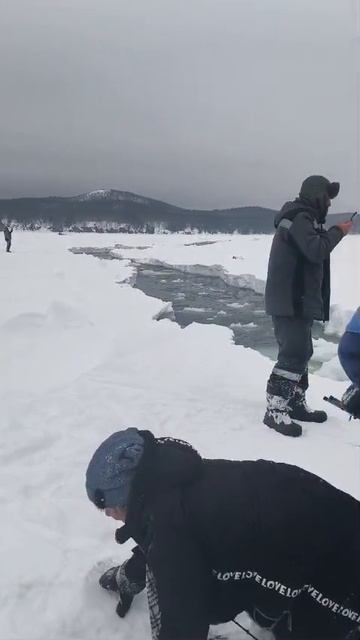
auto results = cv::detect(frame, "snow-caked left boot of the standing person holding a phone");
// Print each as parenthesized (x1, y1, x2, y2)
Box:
(263, 373, 302, 438)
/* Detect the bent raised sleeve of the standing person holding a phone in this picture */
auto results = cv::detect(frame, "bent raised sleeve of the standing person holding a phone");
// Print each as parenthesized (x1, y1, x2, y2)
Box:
(289, 212, 343, 263)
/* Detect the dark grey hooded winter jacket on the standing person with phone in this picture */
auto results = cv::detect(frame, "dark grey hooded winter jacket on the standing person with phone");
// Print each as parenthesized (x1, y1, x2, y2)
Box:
(265, 198, 343, 320)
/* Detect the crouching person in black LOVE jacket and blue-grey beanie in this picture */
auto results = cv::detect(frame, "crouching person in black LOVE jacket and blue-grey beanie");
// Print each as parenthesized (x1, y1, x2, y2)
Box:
(86, 428, 360, 640)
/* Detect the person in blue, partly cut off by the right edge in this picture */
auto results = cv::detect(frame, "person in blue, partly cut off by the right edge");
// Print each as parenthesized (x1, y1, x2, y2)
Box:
(338, 307, 360, 418)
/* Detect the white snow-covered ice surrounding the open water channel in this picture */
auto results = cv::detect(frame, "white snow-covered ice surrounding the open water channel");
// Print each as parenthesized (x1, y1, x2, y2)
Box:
(0, 232, 360, 640)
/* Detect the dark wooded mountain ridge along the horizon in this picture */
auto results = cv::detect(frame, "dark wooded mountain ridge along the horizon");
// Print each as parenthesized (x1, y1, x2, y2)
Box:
(0, 189, 354, 233)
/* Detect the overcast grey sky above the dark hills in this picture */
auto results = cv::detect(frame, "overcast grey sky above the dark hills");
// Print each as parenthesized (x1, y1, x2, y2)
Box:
(0, 0, 360, 210)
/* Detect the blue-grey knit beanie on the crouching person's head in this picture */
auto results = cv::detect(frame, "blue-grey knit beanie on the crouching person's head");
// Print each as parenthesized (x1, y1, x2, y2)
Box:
(86, 427, 144, 509)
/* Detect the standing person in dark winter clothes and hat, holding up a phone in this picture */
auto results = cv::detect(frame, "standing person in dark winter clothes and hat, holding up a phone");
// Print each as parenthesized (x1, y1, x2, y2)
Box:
(264, 176, 352, 437)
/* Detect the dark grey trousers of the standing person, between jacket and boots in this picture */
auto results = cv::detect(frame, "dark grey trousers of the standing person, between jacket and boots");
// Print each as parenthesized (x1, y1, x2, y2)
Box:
(272, 316, 313, 382)
